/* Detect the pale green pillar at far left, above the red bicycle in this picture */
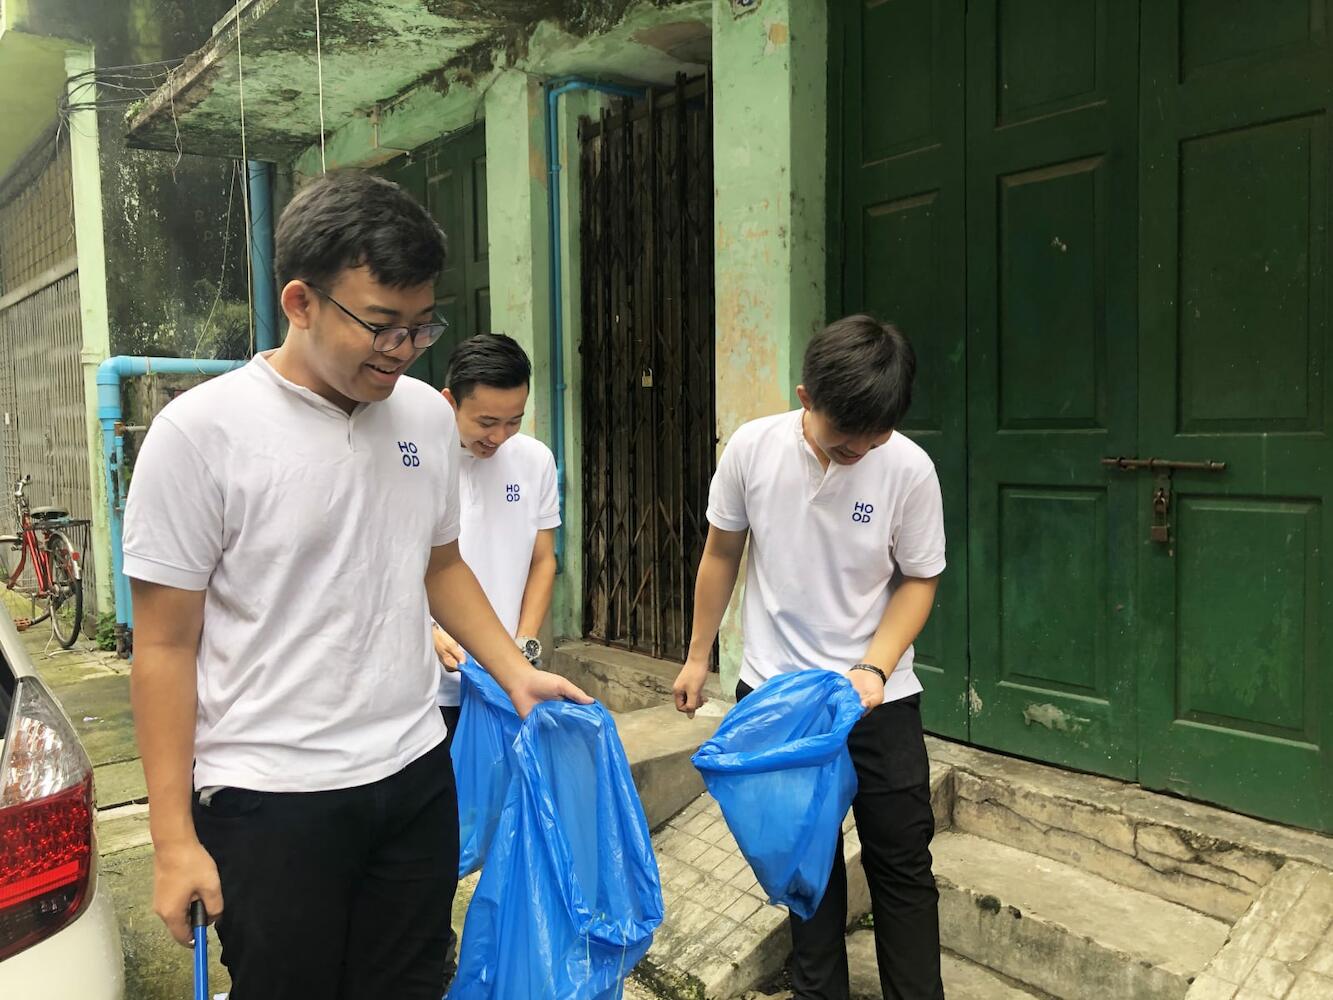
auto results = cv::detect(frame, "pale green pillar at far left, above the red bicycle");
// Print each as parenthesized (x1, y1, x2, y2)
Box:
(65, 48, 113, 613)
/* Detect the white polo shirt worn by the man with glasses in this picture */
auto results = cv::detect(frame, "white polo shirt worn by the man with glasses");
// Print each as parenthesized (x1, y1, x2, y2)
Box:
(124, 357, 459, 792)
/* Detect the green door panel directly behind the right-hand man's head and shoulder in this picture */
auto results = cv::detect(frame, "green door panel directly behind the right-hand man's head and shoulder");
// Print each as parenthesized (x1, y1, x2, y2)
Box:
(830, 0, 968, 737)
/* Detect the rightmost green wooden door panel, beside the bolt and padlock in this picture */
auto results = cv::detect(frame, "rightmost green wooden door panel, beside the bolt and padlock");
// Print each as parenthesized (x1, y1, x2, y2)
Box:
(1125, 0, 1333, 829)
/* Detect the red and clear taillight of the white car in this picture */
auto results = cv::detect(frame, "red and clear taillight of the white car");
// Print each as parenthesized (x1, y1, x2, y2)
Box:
(0, 677, 93, 960)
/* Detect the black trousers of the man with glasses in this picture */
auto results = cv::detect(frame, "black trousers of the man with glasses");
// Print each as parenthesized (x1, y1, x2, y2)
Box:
(195, 743, 459, 1000)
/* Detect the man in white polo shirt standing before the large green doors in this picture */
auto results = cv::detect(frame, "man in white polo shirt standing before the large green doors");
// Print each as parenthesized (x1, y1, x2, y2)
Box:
(674, 316, 944, 1000)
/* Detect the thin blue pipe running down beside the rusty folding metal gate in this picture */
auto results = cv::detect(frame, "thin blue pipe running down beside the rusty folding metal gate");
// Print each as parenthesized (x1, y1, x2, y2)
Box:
(547, 80, 644, 572)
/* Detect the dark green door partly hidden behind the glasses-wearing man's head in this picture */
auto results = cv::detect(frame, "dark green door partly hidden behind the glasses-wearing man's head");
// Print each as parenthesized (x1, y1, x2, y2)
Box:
(383, 125, 491, 389)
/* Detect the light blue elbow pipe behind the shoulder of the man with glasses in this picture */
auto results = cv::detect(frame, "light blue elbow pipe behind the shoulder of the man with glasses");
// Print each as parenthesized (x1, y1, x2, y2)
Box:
(97, 356, 245, 656)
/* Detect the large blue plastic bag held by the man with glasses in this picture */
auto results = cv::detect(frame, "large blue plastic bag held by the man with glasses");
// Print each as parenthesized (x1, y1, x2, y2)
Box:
(448, 701, 663, 1000)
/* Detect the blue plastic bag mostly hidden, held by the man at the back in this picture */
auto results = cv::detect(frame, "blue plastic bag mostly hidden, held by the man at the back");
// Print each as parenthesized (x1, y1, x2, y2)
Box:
(451, 656, 521, 879)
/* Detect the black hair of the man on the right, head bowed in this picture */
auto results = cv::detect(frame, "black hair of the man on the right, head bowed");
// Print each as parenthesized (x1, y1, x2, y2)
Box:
(801, 315, 916, 435)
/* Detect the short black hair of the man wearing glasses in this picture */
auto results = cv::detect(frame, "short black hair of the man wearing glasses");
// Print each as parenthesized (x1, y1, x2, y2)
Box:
(273, 171, 448, 289)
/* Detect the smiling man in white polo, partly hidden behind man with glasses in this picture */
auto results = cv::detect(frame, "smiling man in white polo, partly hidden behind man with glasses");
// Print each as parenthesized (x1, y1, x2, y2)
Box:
(421, 333, 560, 972)
